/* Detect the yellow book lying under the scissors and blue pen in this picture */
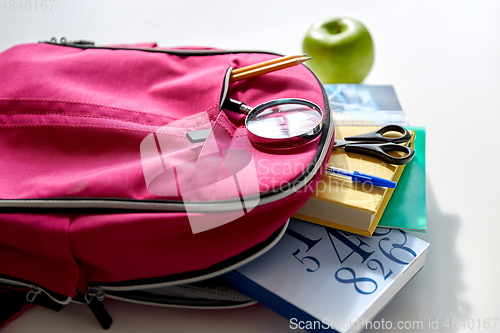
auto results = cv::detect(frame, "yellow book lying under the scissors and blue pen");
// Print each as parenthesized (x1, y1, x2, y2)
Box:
(294, 126, 413, 236)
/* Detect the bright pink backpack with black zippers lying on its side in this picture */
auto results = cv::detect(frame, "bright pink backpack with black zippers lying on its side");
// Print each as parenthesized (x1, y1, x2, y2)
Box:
(0, 40, 334, 328)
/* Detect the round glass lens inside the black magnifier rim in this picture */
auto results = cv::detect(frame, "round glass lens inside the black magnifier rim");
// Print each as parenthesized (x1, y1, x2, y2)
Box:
(247, 103, 323, 139)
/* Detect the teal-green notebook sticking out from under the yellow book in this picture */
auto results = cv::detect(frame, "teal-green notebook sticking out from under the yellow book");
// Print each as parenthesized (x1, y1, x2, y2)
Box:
(378, 126, 427, 232)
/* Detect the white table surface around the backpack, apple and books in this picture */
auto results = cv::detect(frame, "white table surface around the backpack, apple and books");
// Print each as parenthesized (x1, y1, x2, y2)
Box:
(0, 0, 500, 333)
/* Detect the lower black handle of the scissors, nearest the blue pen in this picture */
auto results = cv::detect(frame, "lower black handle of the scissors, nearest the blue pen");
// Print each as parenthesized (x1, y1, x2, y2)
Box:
(344, 142, 415, 165)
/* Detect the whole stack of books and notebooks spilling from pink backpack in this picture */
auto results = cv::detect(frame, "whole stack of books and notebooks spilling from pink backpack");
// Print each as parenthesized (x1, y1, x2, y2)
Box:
(224, 85, 429, 333)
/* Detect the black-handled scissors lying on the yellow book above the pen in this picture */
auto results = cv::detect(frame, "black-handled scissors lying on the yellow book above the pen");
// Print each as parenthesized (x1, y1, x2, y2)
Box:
(333, 125, 415, 165)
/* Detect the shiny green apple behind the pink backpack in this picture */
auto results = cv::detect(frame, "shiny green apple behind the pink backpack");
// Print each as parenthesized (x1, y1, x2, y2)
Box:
(302, 18, 374, 83)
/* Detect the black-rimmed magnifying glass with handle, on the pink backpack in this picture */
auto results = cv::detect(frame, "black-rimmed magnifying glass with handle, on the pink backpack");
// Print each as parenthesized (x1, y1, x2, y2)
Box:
(222, 98, 323, 148)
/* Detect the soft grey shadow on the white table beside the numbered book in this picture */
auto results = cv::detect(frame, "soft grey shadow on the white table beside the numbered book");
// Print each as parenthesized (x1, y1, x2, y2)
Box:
(364, 184, 471, 333)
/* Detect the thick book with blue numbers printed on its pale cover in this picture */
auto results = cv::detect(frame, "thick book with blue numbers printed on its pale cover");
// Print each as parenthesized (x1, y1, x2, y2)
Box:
(223, 218, 429, 333)
